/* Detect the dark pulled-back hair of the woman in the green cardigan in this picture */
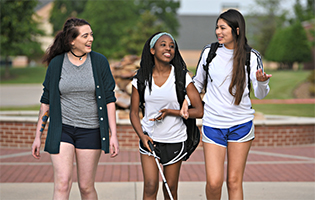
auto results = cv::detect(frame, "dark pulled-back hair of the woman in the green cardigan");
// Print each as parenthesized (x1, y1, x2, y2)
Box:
(43, 18, 91, 65)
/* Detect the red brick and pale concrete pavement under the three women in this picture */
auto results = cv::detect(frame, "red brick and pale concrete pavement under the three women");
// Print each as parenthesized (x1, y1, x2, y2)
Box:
(0, 145, 315, 200)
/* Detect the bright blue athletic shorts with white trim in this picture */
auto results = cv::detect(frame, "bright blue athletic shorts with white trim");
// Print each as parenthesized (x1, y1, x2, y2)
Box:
(202, 121, 255, 147)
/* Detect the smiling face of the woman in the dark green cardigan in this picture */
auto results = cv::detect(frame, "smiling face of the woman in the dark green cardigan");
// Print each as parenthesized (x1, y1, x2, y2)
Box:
(71, 25, 93, 55)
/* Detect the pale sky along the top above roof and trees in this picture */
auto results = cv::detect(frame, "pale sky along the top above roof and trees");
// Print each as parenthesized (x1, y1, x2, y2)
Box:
(178, 0, 306, 15)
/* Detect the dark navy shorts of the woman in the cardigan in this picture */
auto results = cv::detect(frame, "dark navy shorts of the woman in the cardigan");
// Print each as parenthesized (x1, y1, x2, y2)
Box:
(61, 124, 101, 149)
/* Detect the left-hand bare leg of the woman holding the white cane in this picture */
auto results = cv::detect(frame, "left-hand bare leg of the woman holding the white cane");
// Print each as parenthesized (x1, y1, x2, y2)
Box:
(140, 154, 159, 199)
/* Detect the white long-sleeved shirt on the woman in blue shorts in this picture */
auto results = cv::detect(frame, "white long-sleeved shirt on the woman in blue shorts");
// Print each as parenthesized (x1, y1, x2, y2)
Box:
(194, 45, 270, 128)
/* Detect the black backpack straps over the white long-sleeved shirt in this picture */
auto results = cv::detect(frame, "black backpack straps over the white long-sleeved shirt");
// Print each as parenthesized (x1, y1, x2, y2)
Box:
(196, 42, 252, 96)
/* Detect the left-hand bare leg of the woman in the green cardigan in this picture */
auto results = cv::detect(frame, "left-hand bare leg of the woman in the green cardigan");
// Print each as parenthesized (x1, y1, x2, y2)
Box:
(50, 142, 75, 200)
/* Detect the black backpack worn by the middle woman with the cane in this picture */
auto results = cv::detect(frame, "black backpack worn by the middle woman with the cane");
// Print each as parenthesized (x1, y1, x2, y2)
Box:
(135, 69, 200, 161)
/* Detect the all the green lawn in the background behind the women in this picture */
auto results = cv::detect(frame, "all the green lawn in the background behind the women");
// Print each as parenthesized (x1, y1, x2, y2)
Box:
(0, 67, 315, 117)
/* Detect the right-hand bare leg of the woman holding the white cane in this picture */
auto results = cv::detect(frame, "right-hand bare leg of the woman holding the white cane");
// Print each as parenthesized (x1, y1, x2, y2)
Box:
(163, 161, 182, 199)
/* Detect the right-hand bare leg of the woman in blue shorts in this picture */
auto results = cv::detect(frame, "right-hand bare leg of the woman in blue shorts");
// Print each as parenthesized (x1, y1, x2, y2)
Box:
(226, 141, 252, 200)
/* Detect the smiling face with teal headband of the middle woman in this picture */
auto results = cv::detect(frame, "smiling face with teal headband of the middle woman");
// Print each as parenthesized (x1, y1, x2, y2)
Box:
(150, 35, 175, 63)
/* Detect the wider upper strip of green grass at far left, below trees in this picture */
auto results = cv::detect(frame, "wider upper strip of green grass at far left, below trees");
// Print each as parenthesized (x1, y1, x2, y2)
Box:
(0, 66, 46, 84)
